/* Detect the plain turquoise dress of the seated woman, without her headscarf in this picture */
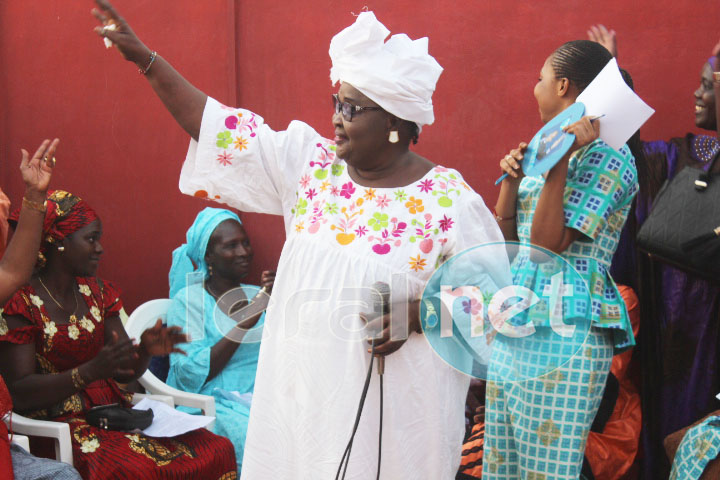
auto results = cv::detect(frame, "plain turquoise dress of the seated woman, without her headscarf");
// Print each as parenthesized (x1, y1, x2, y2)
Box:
(167, 283, 265, 471)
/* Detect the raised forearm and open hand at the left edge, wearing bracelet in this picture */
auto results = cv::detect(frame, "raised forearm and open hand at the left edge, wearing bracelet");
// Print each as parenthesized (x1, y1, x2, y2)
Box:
(0, 138, 60, 305)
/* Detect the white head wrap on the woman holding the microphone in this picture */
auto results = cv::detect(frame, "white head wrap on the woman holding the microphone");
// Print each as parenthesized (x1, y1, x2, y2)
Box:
(330, 12, 442, 127)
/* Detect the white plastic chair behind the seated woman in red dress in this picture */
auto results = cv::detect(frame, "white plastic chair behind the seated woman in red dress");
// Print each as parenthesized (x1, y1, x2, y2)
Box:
(125, 298, 215, 428)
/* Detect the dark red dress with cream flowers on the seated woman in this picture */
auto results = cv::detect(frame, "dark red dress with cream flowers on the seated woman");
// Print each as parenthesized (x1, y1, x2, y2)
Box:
(0, 278, 237, 480)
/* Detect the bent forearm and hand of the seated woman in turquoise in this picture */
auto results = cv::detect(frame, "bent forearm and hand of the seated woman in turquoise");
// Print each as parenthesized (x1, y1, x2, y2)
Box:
(206, 271, 275, 381)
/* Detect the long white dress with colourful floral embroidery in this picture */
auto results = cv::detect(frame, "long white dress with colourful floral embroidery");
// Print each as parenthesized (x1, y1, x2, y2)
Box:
(180, 99, 502, 480)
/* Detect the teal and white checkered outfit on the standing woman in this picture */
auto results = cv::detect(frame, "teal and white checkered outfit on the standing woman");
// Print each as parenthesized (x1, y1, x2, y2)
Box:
(483, 139, 638, 480)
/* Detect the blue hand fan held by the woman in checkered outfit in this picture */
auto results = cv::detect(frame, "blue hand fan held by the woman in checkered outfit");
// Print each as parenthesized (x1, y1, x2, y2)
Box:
(495, 103, 585, 185)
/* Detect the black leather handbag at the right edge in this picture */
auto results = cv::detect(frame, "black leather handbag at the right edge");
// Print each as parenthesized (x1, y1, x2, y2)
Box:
(637, 151, 720, 283)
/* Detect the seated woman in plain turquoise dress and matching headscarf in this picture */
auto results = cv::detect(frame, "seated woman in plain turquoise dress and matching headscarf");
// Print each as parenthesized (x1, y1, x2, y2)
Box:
(167, 208, 275, 471)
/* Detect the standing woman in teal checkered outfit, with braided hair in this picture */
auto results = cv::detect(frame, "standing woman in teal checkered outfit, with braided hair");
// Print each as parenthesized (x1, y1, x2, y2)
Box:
(492, 40, 638, 480)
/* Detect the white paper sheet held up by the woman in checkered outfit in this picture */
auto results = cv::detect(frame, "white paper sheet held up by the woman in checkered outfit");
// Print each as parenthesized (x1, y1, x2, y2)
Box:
(577, 58, 655, 150)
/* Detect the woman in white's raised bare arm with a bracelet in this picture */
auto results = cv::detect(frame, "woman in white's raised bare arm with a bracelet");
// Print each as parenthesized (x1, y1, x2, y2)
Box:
(93, 0, 207, 140)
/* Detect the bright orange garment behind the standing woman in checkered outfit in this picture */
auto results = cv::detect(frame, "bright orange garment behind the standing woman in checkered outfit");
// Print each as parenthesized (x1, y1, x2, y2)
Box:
(585, 285, 642, 480)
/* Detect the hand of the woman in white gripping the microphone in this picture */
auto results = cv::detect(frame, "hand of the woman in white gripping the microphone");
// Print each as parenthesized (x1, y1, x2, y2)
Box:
(365, 300, 420, 357)
